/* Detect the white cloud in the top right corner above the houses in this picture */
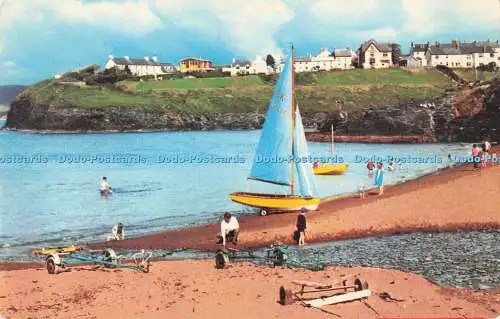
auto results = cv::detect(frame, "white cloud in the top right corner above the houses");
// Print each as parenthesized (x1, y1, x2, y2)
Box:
(402, 0, 500, 36)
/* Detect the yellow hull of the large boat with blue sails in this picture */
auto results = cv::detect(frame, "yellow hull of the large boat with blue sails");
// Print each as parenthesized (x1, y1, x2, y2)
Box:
(229, 192, 320, 211)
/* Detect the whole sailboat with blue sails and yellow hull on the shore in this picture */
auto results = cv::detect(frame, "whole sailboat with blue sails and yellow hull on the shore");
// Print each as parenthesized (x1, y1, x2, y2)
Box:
(229, 46, 320, 216)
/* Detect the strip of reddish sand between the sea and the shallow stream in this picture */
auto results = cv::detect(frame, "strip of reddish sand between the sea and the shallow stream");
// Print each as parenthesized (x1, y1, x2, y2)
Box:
(86, 165, 500, 255)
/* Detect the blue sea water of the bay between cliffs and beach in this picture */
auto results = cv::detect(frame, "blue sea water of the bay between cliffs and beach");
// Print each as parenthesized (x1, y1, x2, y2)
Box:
(0, 121, 469, 260)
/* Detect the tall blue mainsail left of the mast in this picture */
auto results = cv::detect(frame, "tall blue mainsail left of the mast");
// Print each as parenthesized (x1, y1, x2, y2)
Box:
(249, 49, 293, 185)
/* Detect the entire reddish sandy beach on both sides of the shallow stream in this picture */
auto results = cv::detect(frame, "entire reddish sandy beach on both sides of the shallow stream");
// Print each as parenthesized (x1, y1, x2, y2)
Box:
(0, 151, 500, 319)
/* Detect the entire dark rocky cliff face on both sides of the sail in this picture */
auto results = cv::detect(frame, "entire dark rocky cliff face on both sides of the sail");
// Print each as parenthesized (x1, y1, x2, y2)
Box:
(6, 79, 500, 142)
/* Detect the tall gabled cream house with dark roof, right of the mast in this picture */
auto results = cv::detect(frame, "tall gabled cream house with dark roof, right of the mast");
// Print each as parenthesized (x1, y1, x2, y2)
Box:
(358, 39, 392, 69)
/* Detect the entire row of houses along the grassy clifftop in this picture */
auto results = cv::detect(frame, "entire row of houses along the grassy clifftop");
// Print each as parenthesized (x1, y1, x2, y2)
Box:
(105, 39, 500, 77)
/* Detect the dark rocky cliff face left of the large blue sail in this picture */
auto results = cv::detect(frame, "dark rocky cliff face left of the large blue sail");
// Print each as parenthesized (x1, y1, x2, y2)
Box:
(5, 97, 264, 132)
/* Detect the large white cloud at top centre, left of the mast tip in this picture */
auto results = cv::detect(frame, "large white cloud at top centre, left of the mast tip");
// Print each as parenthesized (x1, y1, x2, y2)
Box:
(155, 0, 294, 55)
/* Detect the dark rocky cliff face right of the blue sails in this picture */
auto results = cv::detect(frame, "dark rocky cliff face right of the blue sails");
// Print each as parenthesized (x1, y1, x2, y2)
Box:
(313, 79, 500, 142)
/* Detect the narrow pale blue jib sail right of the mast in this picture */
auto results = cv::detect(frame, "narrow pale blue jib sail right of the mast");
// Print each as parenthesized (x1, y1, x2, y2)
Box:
(293, 106, 318, 196)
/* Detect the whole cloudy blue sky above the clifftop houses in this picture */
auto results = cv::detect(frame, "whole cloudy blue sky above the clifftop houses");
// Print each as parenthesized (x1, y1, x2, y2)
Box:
(0, 0, 500, 85)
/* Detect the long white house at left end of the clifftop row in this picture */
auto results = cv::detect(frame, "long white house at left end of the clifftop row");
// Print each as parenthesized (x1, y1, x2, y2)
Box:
(104, 55, 176, 76)
